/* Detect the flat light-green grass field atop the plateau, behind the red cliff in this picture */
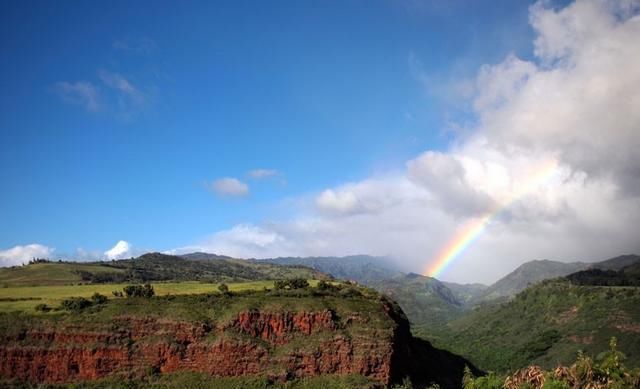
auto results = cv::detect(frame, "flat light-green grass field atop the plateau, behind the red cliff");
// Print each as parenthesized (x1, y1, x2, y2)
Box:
(0, 280, 318, 312)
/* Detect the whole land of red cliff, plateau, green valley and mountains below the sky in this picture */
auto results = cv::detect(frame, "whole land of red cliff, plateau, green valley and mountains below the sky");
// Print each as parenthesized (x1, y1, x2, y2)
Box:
(0, 253, 640, 388)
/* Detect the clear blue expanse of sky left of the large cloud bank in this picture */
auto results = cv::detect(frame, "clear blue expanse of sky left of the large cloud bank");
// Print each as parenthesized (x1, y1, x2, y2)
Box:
(0, 1, 531, 252)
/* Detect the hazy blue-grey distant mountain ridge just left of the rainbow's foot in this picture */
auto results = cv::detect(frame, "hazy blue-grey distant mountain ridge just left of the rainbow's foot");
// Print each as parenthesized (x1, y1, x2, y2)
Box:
(253, 255, 402, 285)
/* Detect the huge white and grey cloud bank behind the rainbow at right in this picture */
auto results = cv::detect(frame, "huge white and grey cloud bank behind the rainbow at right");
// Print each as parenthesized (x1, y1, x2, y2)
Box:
(175, 0, 640, 282)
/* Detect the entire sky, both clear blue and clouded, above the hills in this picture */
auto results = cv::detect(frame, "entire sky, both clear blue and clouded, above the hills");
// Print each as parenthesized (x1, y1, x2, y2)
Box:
(0, 0, 640, 282)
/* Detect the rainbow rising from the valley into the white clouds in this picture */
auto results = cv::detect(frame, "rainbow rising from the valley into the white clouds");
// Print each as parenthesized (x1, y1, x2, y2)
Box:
(422, 160, 558, 277)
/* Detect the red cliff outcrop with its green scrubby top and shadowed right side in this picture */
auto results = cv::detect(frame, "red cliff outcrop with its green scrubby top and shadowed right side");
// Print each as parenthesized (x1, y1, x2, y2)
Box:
(0, 294, 480, 389)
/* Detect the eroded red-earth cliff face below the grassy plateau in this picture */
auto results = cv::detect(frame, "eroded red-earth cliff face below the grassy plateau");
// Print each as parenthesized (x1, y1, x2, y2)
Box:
(0, 301, 410, 384)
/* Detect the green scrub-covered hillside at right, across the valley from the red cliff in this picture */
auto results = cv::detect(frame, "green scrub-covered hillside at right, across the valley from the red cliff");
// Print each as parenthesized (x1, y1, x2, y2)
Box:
(437, 279, 640, 372)
